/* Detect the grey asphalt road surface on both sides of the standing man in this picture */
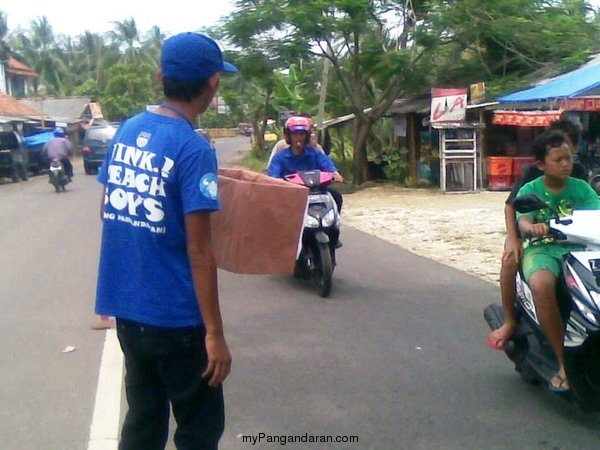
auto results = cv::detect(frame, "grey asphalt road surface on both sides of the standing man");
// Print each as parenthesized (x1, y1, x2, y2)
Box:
(0, 138, 600, 450)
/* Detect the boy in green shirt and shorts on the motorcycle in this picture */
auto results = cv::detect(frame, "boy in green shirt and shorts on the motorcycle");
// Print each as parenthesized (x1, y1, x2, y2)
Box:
(517, 131, 600, 391)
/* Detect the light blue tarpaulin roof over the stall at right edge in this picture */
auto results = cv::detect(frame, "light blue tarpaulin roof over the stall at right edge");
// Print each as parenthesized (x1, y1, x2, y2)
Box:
(498, 60, 600, 103)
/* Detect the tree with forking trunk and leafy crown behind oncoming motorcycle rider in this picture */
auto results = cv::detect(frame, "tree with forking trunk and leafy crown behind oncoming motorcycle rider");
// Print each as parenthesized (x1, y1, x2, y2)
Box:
(227, 0, 421, 184)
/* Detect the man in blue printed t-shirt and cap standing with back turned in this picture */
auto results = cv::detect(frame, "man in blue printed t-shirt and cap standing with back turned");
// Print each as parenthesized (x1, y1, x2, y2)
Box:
(96, 33, 237, 450)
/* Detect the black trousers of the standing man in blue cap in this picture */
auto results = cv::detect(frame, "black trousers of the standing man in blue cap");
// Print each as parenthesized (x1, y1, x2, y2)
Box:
(117, 318, 225, 450)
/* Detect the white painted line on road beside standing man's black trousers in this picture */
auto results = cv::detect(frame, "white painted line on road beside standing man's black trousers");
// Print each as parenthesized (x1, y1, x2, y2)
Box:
(88, 329, 123, 450)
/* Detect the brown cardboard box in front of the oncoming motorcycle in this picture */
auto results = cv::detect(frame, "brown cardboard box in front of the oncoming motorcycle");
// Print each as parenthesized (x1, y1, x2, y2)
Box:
(211, 169, 308, 274)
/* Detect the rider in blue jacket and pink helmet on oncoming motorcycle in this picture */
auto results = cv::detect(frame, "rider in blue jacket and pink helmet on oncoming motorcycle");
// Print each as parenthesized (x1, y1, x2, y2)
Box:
(267, 116, 344, 212)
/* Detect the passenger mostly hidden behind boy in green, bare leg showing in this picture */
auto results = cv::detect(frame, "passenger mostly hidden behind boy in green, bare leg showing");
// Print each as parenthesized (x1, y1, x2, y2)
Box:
(486, 119, 587, 350)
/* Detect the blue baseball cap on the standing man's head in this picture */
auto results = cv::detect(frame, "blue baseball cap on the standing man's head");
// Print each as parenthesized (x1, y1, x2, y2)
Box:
(160, 32, 238, 81)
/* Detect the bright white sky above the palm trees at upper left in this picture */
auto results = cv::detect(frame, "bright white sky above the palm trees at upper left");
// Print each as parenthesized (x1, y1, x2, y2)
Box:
(0, 0, 234, 36)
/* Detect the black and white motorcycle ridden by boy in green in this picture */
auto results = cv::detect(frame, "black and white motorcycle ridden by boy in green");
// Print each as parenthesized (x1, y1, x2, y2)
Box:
(484, 194, 600, 412)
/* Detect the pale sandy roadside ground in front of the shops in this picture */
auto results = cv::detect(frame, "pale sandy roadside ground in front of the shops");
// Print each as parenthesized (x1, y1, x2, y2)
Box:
(342, 186, 508, 284)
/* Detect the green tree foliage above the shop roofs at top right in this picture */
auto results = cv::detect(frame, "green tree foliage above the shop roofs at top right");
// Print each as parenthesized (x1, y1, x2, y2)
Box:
(420, 0, 599, 95)
